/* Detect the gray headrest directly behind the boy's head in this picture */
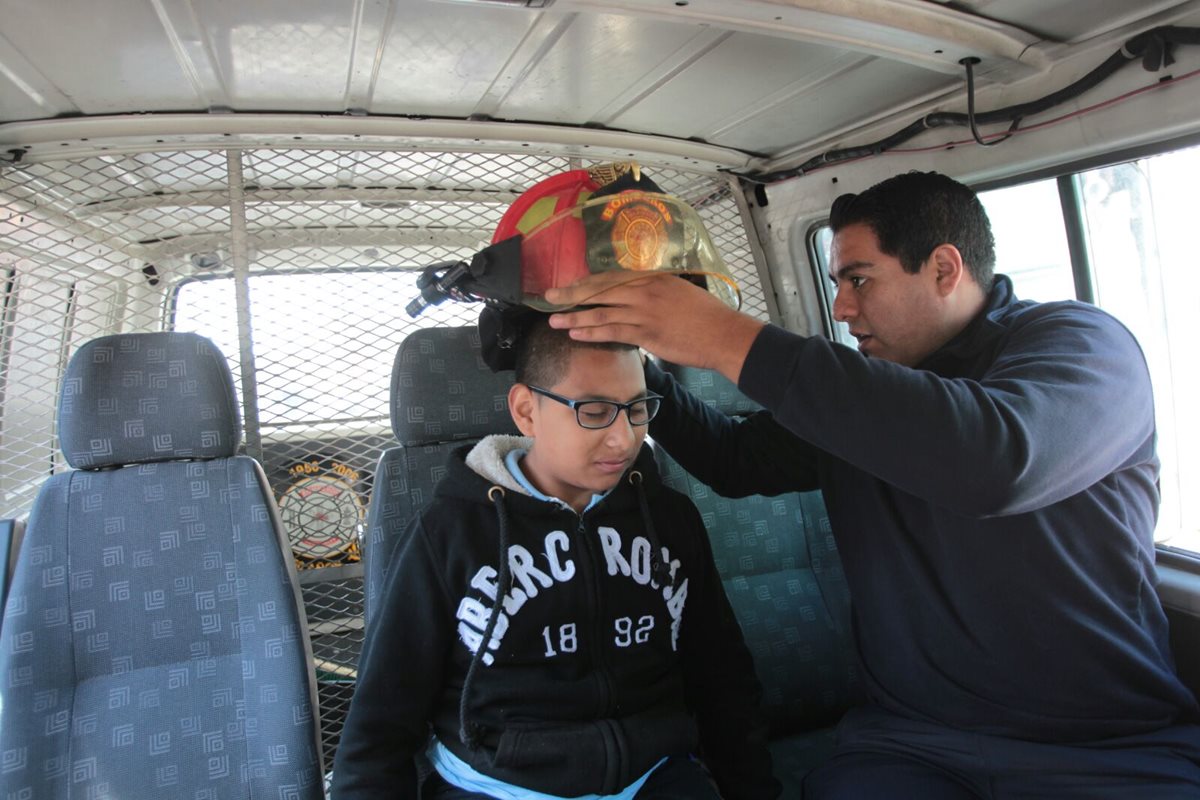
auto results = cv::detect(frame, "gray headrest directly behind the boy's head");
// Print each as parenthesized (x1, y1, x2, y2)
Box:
(391, 325, 517, 446)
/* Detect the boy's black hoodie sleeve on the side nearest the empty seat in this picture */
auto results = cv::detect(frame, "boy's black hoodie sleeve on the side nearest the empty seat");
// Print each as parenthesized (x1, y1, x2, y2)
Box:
(331, 519, 454, 800)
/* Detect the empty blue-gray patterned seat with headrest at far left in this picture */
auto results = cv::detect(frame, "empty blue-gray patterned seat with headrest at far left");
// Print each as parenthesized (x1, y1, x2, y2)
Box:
(0, 333, 323, 800)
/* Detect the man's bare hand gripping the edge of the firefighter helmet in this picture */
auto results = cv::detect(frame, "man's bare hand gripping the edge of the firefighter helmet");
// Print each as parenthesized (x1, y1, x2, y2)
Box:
(546, 271, 763, 383)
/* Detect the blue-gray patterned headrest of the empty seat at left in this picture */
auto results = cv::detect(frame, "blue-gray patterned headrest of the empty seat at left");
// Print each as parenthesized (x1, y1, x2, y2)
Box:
(59, 331, 241, 469)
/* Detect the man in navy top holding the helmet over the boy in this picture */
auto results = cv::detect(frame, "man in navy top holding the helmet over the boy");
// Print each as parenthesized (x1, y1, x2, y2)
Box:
(547, 173, 1200, 799)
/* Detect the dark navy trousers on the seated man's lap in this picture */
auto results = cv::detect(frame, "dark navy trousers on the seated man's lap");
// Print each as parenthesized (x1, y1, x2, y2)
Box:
(804, 706, 1200, 800)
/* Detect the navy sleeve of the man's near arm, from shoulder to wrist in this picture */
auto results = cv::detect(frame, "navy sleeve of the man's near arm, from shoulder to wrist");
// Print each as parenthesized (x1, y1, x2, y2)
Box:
(739, 303, 1154, 518)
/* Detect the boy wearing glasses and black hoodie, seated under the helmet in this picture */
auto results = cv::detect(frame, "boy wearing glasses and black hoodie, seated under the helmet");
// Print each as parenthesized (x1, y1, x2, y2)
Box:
(334, 314, 779, 800)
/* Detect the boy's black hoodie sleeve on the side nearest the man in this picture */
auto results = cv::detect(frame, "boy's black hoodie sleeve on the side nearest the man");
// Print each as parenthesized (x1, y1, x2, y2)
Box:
(679, 500, 782, 800)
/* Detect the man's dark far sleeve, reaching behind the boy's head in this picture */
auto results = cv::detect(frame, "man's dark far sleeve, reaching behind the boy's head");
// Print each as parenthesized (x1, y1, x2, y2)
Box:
(646, 361, 817, 498)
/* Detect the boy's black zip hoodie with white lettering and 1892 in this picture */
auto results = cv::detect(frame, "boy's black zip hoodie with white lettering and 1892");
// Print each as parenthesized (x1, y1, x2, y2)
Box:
(334, 437, 779, 800)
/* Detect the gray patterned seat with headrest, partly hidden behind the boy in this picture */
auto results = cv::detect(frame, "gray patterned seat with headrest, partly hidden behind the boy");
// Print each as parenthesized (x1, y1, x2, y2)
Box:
(362, 325, 517, 631)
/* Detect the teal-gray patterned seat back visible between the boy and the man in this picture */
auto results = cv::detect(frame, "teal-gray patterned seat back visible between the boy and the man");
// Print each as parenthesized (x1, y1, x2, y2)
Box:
(658, 367, 863, 798)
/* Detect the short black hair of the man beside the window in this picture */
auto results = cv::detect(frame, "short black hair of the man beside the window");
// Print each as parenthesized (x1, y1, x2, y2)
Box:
(829, 172, 996, 291)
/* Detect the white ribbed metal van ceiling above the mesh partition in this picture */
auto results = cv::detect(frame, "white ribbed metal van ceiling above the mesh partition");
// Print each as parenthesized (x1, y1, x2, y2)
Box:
(0, 0, 1198, 170)
